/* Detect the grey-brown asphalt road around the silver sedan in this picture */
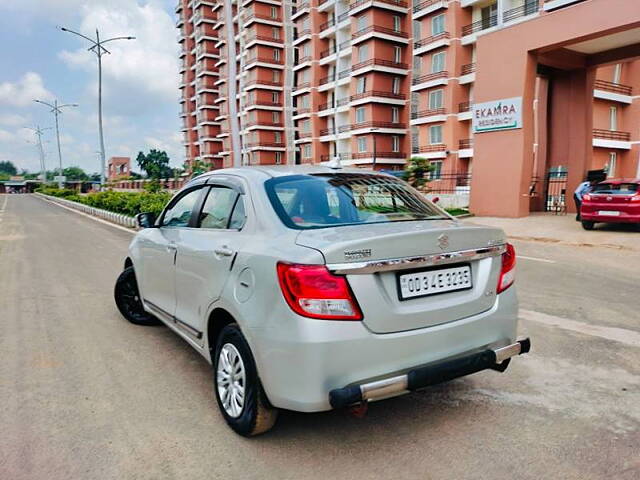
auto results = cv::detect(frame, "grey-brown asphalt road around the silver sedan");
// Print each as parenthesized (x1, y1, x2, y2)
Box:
(0, 195, 640, 480)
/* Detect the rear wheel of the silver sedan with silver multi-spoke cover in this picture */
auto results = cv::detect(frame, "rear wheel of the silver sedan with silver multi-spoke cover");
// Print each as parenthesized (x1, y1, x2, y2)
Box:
(213, 323, 278, 437)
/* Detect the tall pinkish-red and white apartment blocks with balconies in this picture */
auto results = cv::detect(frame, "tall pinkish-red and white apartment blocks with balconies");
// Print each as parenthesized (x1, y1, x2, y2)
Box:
(176, 0, 640, 191)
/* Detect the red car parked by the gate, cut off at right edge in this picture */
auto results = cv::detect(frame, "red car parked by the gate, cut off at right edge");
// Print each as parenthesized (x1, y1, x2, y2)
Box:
(580, 178, 640, 230)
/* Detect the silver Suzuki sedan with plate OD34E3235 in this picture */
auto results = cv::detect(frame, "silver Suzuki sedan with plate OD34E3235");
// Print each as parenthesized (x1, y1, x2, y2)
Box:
(115, 166, 530, 435)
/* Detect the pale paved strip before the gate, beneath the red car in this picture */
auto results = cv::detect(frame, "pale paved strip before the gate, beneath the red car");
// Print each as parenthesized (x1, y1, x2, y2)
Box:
(466, 213, 640, 251)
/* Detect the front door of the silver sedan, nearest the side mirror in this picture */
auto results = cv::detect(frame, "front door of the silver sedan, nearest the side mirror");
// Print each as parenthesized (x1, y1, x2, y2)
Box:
(139, 186, 203, 319)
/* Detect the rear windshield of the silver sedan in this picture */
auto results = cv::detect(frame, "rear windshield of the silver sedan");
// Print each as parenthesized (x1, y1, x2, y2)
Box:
(265, 173, 449, 229)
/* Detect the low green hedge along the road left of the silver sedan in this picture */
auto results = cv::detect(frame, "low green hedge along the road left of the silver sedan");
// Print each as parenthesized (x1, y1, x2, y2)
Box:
(36, 187, 172, 217)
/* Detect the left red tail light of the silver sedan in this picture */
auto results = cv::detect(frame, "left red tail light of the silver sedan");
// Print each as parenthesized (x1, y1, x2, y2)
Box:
(278, 263, 362, 320)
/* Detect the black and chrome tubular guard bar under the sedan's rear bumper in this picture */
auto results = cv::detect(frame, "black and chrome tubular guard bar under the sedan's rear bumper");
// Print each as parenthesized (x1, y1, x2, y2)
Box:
(329, 338, 531, 408)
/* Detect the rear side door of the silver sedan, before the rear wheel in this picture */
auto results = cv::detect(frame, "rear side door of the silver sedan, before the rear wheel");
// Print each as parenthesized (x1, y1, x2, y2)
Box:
(175, 184, 246, 339)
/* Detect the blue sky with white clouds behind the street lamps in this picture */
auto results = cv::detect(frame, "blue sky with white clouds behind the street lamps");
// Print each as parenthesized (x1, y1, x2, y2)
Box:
(0, 0, 184, 173)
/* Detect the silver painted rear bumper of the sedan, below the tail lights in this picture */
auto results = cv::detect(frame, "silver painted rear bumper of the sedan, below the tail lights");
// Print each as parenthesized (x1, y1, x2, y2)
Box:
(246, 287, 518, 412)
